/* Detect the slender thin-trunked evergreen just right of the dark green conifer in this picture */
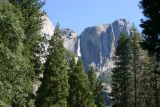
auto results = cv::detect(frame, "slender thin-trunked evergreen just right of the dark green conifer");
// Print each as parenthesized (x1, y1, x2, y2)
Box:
(131, 26, 143, 107)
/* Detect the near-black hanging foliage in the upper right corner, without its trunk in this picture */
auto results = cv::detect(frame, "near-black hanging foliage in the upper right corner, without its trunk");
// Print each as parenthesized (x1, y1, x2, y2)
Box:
(140, 0, 160, 55)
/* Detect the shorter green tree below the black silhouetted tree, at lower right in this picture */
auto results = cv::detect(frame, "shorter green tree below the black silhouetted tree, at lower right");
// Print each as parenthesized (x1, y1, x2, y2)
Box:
(137, 51, 155, 107)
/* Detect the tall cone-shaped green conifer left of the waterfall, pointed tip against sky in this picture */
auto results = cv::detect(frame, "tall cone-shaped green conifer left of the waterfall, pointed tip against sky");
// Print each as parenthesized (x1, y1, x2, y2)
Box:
(35, 25, 69, 107)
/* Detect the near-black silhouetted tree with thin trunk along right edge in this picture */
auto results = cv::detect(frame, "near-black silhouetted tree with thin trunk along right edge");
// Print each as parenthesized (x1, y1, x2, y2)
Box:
(140, 0, 160, 107)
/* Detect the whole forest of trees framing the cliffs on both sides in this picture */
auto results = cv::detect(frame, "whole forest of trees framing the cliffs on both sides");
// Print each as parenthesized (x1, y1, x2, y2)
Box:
(0, 0, 160, 107)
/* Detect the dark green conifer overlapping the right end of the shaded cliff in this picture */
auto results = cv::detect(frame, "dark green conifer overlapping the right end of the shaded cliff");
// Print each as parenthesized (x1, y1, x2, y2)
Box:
(111, 34, 133, 107)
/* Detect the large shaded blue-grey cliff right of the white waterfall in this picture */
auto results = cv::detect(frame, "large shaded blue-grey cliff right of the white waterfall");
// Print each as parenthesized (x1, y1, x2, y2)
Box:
(79, 19, 131, 72)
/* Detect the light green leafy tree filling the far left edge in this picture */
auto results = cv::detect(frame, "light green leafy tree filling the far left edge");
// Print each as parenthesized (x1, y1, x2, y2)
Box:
(0, 0, 32, 107)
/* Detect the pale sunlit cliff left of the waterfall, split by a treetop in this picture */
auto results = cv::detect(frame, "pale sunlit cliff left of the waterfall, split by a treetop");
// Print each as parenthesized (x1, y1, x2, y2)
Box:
(41, 15, 78, 56)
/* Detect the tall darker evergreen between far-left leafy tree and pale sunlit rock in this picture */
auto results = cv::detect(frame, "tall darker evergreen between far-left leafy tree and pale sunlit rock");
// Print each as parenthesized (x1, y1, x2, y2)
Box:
(7, 0, 44, 106)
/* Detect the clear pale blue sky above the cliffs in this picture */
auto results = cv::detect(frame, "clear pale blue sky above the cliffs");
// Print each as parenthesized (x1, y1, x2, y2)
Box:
(44, 0, 143, 34)
